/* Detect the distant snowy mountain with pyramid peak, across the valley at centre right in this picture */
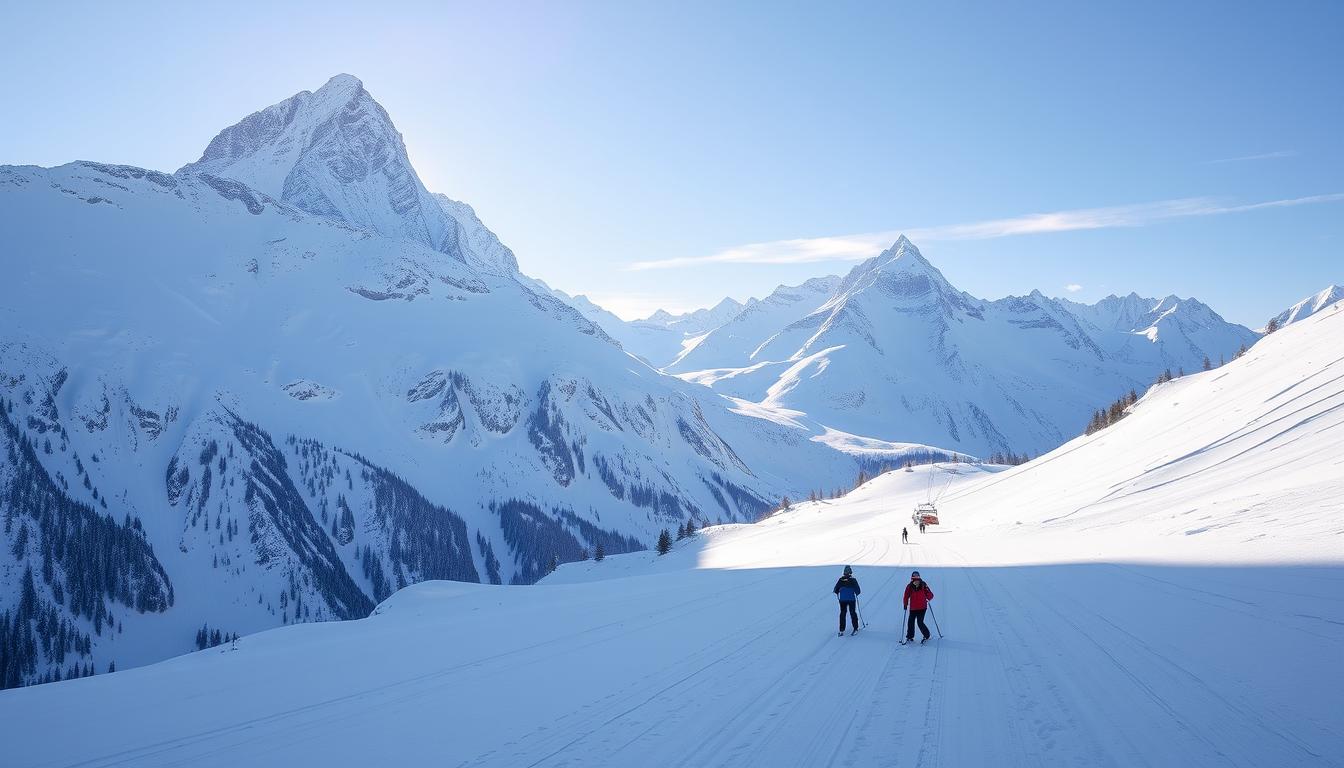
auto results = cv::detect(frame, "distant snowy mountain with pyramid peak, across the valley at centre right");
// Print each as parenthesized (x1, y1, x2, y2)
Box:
(669, 238, 1255, 456)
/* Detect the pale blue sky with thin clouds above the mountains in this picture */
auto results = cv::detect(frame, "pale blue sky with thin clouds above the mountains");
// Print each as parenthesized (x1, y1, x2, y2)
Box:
(0, 1, 1344, 325)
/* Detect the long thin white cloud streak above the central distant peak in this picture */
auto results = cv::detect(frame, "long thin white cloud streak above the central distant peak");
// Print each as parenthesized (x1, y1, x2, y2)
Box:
(626, 192, 1344, 272)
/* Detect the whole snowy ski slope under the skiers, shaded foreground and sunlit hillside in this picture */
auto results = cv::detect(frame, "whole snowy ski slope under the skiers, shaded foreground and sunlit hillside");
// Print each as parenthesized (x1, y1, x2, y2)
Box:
(0, 303, 1344, 767)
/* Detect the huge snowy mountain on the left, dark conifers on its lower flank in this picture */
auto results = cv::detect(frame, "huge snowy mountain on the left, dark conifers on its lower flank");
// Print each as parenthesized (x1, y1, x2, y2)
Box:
(0, 78, 903, 682)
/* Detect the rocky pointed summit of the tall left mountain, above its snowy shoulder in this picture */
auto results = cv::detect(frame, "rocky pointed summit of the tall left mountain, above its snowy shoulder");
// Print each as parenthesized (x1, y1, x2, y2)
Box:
(177, 74, 517, 274)
